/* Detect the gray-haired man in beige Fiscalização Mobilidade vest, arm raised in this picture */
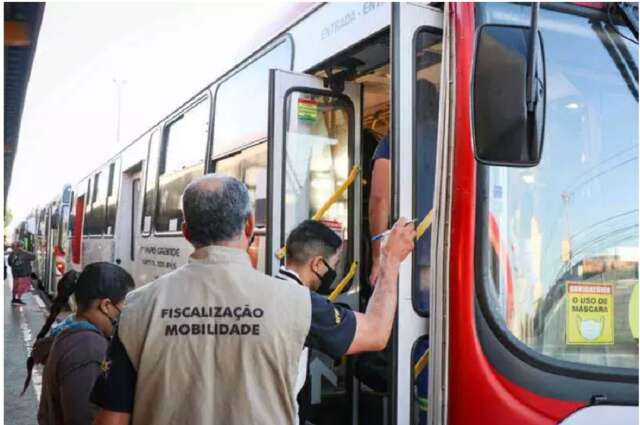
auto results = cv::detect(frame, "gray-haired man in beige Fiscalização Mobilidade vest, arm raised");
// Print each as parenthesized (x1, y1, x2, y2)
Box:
(91, 175, 415, 425)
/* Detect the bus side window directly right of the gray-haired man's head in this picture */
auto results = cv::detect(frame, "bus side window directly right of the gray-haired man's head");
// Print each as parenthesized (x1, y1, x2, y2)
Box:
(214, 143, 267, 271)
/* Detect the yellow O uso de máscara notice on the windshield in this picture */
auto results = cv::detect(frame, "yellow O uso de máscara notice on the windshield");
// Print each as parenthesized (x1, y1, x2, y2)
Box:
(566, 282, 614, 345)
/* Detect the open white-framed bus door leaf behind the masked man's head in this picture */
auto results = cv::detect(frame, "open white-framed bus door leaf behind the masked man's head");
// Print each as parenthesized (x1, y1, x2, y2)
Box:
(267, 70, 362, 424)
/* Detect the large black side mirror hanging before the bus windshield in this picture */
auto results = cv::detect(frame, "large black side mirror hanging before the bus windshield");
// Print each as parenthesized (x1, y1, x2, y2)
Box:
(472, 25, 546, 167)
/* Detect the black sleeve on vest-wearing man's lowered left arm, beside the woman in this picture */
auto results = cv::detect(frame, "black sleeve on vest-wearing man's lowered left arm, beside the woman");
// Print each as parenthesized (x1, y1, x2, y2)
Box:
(91, 332, 137, 413)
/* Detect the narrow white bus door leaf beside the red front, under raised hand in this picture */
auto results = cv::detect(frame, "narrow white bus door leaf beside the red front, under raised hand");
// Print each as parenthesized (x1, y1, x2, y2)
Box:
(391, 3, 446, 424)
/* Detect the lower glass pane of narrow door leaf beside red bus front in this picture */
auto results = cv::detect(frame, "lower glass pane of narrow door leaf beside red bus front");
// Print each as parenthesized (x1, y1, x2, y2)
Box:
(411, 336, 429, 425)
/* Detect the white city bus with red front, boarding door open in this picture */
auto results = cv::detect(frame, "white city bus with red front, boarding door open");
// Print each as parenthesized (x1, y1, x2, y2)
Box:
(23, 3, 638, 425)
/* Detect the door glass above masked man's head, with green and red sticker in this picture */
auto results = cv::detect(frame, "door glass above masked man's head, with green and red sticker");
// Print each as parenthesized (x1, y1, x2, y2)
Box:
(282, 92, 353, 279)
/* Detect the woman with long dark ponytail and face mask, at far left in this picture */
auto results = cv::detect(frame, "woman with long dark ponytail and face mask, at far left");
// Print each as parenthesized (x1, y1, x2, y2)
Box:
(24, 262, 134, 425)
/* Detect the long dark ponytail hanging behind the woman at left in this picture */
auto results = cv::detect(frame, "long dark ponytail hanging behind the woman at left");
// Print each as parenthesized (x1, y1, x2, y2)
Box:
(20, 270, 80, 396)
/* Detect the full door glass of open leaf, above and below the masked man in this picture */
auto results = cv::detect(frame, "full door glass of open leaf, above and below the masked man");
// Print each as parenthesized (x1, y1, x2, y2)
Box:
(281, 91, 359, 423)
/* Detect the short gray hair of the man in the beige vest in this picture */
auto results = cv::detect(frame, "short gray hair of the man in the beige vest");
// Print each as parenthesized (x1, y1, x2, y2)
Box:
(182, 174, 251, 246)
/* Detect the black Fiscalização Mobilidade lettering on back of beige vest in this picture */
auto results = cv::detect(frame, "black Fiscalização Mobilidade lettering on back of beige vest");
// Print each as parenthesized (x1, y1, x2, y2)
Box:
(165, 304, 264, 336)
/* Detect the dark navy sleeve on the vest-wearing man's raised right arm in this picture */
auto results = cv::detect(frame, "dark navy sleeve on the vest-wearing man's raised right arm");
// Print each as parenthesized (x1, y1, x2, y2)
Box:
(305, 292, 356, 359)
